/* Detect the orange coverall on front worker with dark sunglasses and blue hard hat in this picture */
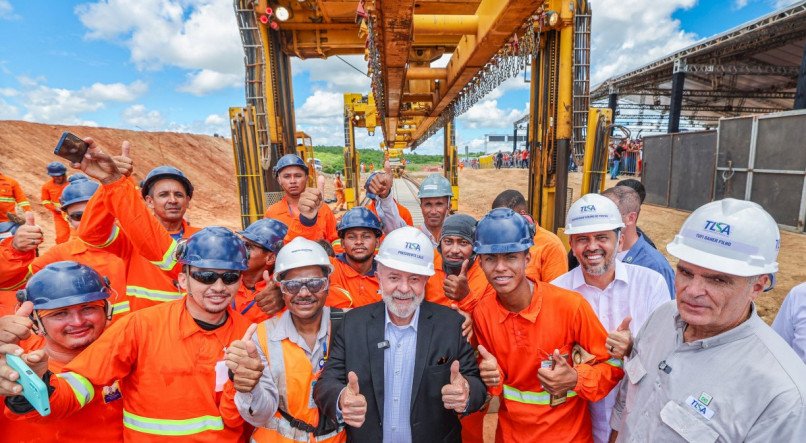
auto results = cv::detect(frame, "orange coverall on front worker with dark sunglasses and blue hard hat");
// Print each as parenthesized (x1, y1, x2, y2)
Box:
(34, 298, 249, 442)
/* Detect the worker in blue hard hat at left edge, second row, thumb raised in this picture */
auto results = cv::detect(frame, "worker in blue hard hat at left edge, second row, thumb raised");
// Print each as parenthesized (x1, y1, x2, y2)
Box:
(0, 174, 126, 321)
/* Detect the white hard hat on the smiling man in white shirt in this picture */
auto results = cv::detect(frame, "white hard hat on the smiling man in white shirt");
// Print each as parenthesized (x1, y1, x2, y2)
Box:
(565, 193, 624, 235)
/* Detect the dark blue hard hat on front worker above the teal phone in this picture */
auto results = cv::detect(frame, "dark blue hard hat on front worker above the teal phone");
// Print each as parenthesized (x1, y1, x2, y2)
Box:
(17, 261, 109, 309)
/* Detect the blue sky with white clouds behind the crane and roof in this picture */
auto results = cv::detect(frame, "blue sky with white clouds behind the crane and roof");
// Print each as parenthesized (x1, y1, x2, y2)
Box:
(0, 0, 794, 152)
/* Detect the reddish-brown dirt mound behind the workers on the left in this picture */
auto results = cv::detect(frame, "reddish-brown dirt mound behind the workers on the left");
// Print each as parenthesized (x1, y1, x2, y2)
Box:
(0, 121, 240, 247)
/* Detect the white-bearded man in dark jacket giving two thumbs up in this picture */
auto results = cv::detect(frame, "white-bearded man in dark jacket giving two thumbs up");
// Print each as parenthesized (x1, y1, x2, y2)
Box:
(314, 226, 486, 443)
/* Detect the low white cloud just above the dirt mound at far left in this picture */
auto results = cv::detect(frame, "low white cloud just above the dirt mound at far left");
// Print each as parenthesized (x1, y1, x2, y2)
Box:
(17, 76, 148, 126)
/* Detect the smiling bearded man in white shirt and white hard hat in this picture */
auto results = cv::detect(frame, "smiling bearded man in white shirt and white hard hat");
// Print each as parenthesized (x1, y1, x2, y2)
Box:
(551, 194, 671, 443)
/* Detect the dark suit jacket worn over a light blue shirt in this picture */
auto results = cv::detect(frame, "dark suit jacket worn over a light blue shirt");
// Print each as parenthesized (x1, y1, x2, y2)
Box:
(314, 301, 487, 442)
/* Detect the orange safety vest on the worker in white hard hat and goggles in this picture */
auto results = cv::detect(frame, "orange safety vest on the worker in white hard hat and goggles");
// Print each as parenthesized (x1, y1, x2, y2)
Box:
(251, 316, 347, 443)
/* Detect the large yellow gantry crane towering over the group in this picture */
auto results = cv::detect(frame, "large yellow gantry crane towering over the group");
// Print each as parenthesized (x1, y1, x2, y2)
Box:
(230, 0, 606, 231)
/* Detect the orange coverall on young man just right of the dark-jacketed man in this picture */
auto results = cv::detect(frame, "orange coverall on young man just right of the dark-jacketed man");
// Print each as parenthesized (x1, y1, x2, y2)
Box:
(473, 282, 624, 442)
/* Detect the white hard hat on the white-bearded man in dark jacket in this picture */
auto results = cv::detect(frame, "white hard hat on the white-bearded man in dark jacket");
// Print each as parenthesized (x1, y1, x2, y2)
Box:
(375, 226, 434, 276)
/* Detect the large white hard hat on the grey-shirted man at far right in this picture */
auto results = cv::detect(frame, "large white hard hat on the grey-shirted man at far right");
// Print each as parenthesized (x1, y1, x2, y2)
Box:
(666, 198, 781, 277)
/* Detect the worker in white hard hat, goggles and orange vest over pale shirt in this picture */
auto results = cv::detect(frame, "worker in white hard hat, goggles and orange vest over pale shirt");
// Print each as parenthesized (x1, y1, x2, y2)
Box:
(224, 237, 346, 443)
